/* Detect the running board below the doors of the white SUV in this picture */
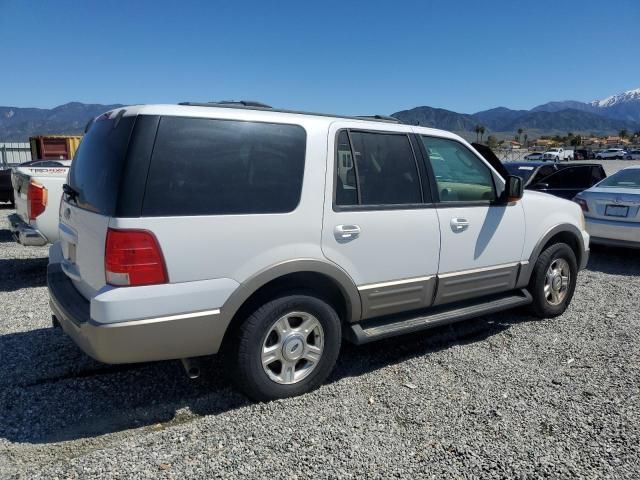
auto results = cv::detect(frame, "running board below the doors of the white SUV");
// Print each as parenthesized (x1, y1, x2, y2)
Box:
(347, 289, 532, 345)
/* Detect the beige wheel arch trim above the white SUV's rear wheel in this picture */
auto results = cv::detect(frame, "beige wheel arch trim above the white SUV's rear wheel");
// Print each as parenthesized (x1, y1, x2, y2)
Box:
(221, 258, 362, 322)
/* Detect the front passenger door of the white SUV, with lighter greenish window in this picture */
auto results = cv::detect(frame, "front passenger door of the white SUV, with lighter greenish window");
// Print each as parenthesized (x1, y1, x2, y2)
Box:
(420, 135, 525, 305)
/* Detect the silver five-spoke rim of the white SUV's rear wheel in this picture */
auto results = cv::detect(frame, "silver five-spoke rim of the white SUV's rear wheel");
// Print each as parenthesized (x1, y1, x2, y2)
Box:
(261, 312, 324, 385)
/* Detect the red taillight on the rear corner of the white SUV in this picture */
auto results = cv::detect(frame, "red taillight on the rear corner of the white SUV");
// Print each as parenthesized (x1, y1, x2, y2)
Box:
(104, 228, 169, 287)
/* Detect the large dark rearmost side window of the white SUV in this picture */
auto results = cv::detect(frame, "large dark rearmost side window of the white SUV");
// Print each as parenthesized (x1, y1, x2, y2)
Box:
(142, 117, 306, 216)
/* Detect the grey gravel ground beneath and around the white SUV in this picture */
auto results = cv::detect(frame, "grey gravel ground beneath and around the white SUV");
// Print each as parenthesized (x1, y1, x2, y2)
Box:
(0, 168, 640, 479)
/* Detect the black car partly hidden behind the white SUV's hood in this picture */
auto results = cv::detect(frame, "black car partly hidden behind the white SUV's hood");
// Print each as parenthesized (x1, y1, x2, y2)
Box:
(504, 162, 607, 200)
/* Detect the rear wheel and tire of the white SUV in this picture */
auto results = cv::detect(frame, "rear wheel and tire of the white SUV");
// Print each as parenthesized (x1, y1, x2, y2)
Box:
(227, 293, 342, 402)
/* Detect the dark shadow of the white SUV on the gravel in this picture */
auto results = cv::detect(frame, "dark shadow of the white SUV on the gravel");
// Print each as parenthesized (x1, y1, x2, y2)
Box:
(0, 311, 530, 444)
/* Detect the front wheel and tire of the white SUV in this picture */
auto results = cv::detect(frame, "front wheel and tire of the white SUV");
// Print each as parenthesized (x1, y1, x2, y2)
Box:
(529, 243, 578, 318)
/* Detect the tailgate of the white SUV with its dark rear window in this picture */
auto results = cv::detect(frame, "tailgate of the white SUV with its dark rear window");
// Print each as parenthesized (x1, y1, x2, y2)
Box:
(60, 115, 136, 298)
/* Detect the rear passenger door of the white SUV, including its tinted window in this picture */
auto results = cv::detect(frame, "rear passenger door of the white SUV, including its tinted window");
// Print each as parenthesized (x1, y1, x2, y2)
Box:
(322, 122, 440, 318)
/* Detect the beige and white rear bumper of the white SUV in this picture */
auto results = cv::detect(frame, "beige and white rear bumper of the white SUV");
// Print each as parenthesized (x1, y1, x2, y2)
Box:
(47, 263, 236, 363)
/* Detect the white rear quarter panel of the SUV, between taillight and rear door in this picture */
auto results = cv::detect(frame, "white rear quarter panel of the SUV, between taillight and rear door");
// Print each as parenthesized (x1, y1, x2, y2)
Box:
(109, 119, 327, 283)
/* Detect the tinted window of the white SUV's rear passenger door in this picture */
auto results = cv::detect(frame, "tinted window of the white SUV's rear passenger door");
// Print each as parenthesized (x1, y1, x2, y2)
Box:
(336, 131, 422, 205)
